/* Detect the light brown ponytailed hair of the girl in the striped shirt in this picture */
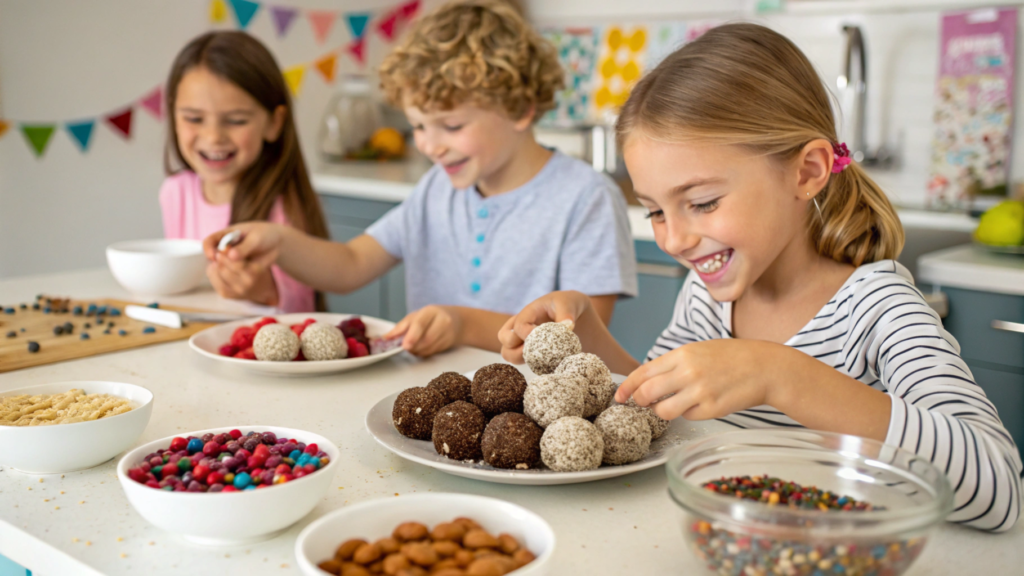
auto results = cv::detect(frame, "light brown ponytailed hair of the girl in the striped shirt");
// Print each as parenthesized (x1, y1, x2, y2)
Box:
(616, 24, 904, 266)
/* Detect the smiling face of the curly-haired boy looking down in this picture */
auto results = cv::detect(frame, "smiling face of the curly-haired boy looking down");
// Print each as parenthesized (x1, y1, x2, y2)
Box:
(406, 105, 532, 189)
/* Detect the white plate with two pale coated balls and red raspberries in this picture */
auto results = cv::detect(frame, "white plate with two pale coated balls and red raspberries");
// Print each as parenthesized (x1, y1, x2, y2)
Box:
(188, 313, 401, 375)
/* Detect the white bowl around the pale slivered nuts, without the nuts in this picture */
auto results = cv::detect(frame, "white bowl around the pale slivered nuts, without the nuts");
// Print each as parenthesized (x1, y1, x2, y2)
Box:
(0, 381, 153, 474)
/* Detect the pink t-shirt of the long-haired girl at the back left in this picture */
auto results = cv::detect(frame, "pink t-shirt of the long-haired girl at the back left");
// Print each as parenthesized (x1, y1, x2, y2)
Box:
(160, 170, 316, 313)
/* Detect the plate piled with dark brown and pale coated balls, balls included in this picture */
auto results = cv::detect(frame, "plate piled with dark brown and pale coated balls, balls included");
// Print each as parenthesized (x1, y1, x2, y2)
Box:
(367, 323, 731, 485)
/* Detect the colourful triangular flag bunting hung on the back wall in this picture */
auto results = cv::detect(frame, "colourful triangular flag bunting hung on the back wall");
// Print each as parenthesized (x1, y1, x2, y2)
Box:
(0, 0, 421, 158)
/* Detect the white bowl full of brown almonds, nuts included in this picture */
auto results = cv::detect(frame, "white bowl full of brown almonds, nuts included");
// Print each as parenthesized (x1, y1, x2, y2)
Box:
(295, 487, 555, 576)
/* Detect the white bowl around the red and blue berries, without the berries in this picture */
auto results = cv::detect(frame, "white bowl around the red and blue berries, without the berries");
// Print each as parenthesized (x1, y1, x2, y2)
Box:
(118, 425, 340, 546)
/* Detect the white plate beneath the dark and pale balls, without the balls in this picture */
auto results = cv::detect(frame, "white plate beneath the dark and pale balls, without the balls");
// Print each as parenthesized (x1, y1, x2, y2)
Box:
(367, 372, 735, 486)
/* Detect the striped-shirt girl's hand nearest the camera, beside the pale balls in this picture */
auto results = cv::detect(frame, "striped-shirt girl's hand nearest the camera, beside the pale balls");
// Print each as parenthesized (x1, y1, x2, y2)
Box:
(615, 339, 781, 420)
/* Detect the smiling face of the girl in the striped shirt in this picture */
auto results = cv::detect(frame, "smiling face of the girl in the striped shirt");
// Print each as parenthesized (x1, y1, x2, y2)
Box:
(623, 134, 816, 302)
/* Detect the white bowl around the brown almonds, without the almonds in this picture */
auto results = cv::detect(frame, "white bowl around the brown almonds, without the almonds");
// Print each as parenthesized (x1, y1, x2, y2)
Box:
(295, 493, 555, 576)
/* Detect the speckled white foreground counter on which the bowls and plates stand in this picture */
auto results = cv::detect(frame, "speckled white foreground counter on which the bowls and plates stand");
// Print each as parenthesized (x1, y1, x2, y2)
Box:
(0, 271, 1024, 576)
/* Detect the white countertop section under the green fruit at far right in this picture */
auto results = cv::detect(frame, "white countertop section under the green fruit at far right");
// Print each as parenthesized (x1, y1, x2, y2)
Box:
(918, 244, 1024, 296)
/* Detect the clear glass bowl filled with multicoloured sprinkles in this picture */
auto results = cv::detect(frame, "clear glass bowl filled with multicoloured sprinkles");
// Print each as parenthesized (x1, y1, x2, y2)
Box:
(666, 429, 953, 576)
